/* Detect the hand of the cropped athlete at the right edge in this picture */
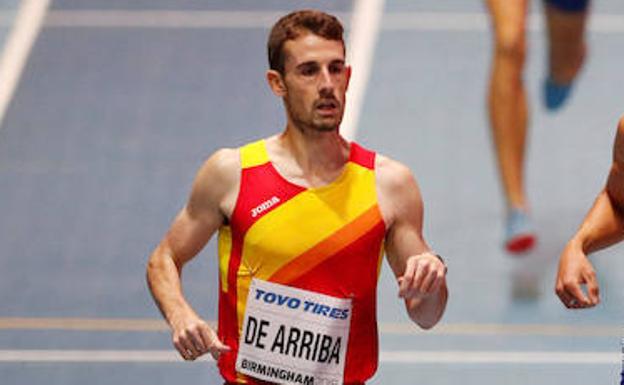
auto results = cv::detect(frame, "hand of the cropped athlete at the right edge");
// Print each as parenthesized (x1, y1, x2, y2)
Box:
(555, 243, 600, 309)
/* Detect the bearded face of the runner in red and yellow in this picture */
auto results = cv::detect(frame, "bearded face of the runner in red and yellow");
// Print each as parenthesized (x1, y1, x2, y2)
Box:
(283, 33, 350, 131)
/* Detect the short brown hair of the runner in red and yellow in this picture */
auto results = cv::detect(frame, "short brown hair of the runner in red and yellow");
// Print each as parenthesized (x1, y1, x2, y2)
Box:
(267, 9, 344, 74)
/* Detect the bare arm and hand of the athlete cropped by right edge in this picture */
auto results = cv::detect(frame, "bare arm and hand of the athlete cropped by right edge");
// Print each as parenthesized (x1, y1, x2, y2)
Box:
(555, 118, 624, 308)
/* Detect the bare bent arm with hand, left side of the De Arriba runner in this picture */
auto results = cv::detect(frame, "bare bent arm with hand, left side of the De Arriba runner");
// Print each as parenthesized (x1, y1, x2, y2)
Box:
(147, 149, 240, 360)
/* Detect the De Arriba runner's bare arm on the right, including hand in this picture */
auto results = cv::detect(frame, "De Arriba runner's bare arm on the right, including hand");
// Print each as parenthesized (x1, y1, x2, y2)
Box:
(376, 156, 448, 329)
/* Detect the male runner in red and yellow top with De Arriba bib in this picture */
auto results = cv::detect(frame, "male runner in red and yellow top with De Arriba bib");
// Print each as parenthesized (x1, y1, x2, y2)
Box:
(147, 10, 447, 384)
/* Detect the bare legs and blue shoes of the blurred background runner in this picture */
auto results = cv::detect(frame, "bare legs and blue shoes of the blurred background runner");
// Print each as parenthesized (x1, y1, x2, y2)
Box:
(487, 0, 589, 253)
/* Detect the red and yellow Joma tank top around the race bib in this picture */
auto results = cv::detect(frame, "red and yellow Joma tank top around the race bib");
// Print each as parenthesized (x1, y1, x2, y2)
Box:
(218, 140, 385, 384)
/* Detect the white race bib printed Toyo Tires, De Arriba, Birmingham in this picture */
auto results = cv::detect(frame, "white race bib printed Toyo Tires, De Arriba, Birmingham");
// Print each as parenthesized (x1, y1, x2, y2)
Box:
(236, 279, 351, 385)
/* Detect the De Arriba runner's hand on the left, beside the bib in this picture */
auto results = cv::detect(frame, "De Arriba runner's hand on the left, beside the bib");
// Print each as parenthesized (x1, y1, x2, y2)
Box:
(171, 313, 230, 361)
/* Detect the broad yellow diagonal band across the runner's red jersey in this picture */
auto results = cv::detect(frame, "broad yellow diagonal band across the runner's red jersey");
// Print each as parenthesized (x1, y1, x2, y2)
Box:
(237, 162, 377, 330)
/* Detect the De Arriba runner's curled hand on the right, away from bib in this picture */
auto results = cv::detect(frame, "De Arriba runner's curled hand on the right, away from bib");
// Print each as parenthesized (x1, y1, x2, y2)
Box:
(398, 252, 446, 299)
